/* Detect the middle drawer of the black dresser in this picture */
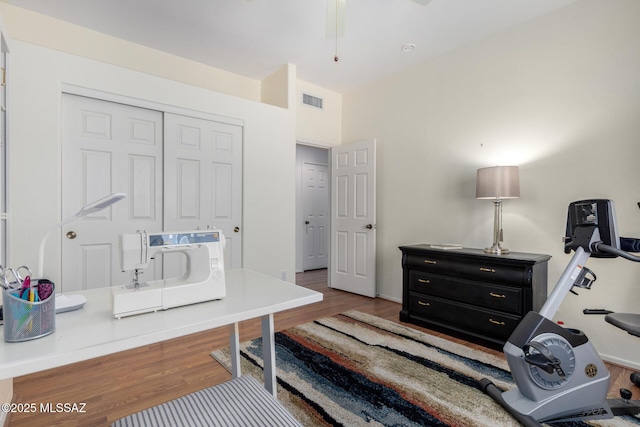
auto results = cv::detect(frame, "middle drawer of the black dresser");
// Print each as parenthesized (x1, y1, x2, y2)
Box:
(409, 270, 525, 315)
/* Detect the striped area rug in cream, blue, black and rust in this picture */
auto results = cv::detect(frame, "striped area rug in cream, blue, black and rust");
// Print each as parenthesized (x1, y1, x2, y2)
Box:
(212, 311, 640, 427)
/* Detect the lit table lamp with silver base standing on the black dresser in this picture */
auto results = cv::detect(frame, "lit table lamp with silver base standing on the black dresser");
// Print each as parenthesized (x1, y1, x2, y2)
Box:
(476, 166, 520, 255)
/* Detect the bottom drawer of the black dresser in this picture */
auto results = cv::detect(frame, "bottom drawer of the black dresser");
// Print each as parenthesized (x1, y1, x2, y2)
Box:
(409, 293, 522, 340)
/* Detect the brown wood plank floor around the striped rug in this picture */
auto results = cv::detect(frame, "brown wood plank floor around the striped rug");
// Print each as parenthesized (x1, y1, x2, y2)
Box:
(8, 270, 640, 427)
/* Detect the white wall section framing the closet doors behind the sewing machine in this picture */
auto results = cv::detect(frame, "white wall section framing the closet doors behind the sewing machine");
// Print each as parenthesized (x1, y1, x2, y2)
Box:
(8, 40, 295, 281)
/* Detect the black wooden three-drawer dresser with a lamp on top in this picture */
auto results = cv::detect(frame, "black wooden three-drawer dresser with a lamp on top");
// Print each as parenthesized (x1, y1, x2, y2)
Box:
(400, 244, 551, 348)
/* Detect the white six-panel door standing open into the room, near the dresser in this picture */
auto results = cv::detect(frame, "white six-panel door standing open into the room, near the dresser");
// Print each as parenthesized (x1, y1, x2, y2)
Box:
(330, 140, 376, 297)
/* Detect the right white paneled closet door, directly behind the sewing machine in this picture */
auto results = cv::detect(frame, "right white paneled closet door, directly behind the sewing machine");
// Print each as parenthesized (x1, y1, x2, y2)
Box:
(164, 113, 242, 274)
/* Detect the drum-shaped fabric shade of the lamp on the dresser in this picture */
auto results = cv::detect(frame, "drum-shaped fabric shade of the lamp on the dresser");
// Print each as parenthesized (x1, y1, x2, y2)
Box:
(476, 166, 520, 199)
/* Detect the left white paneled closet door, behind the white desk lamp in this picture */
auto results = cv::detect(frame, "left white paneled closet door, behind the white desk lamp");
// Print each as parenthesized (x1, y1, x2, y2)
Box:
(59, 94, 162, 292)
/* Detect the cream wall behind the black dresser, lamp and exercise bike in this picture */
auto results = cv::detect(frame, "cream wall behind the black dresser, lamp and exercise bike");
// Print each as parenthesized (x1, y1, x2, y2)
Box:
(342, 0, 640, 367)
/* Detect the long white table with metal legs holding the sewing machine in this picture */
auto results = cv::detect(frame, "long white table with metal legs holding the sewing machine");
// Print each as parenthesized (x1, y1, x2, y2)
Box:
(0, 269, 322, 396)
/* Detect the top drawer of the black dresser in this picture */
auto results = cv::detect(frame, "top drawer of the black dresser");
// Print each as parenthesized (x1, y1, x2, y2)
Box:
(406, 253, 531, 286)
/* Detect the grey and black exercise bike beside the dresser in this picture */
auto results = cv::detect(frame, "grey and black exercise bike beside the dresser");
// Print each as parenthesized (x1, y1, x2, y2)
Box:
(479, 199, 640, 426)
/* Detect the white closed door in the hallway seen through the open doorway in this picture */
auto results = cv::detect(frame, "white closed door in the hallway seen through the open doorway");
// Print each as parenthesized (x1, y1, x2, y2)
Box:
(302, 162, 330, 270)
